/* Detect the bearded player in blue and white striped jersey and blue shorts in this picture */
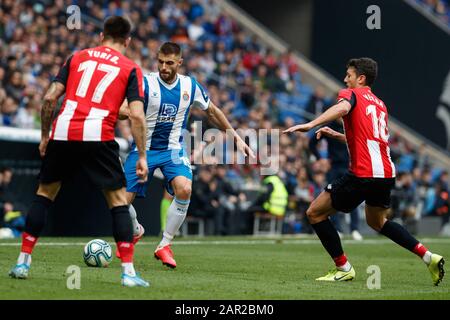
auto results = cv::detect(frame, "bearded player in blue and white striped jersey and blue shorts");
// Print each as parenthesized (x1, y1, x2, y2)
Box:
(121, 42, 255, 268)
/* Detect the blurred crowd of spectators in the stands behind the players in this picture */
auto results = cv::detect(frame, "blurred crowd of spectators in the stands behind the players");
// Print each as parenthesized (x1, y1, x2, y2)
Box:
(0, 0, 449, 234)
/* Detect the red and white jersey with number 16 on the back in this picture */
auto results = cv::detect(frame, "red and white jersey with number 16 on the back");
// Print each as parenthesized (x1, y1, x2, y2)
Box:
(338, 87, 395, 178)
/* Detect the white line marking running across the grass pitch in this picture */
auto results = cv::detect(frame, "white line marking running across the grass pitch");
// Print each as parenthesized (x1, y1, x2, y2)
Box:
(0, 238, 450, 247)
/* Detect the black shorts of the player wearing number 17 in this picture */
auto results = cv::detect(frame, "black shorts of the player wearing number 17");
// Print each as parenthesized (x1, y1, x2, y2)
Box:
(39, 140, 126, 190)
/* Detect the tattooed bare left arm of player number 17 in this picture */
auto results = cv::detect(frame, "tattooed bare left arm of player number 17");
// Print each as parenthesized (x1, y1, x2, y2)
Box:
(39, 81, 66, 157)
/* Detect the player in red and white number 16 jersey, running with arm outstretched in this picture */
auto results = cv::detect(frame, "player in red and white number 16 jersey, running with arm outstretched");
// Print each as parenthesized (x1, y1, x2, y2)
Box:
(285, 58, 444, 285)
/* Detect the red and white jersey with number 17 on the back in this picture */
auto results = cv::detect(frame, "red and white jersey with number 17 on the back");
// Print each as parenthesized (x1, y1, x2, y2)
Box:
(50, 46, 144, 141)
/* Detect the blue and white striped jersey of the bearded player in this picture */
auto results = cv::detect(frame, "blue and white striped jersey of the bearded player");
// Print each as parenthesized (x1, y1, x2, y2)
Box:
(137, 72, 210, 150)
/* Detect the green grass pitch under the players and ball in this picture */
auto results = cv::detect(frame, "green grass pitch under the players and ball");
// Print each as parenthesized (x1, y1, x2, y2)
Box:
(0, 237, 450, 300)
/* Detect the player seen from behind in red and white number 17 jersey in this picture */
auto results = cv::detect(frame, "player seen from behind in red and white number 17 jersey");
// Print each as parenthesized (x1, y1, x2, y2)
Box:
(9, 16, 149, 287)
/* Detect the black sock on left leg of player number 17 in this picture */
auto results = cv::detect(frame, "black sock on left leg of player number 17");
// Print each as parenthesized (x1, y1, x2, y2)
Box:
(24, 195, 53, 238)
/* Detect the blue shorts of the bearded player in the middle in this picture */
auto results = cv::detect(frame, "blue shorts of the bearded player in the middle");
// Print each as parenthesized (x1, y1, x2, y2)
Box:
(125, 149, 192, 198)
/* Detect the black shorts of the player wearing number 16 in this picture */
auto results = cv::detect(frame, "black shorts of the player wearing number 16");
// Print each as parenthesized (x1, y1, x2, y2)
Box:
(325, 173, 395, 212)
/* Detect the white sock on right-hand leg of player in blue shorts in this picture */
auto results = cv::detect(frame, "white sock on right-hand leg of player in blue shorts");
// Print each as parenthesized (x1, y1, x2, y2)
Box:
(158, 197, 189, 247)
